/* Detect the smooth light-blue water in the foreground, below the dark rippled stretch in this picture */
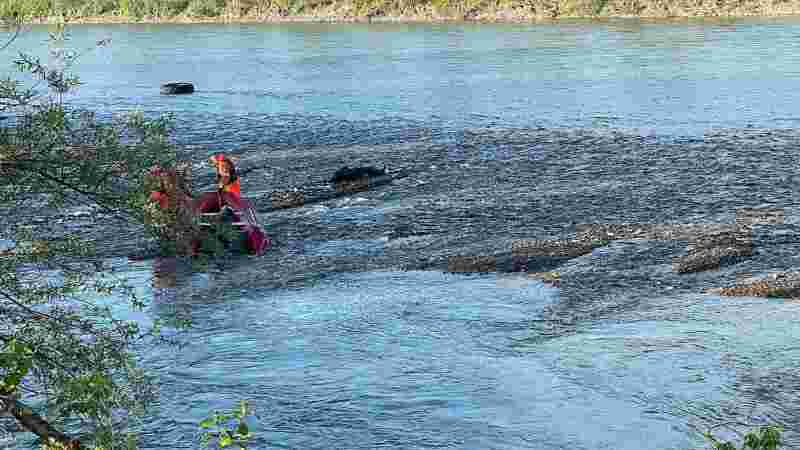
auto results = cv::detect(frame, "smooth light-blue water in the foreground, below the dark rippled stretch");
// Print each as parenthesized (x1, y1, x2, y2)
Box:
(47, 261, 800, 450)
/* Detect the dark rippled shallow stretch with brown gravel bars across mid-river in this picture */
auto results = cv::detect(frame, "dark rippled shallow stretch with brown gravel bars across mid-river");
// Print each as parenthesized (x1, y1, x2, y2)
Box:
(8, 129, 800, 295)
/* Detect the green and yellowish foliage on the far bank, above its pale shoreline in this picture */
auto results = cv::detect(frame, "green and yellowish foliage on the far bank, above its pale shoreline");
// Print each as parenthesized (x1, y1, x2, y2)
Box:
(0, 0, 797, 19)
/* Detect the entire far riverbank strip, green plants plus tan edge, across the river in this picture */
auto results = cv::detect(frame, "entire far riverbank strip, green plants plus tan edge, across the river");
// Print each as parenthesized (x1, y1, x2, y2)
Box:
(0, 0, 800, 22)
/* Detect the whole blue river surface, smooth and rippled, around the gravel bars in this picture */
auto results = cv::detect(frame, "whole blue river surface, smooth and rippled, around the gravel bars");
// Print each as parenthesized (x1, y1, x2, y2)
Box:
(1, 19, 800, 450)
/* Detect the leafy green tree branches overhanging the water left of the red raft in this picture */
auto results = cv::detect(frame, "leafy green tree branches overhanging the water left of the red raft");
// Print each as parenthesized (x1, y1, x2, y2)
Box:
(0, 15, 186, 449)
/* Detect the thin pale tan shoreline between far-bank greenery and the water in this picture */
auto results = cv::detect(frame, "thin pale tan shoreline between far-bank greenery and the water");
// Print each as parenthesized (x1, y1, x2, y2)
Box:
(21, 9, 800, 25)
